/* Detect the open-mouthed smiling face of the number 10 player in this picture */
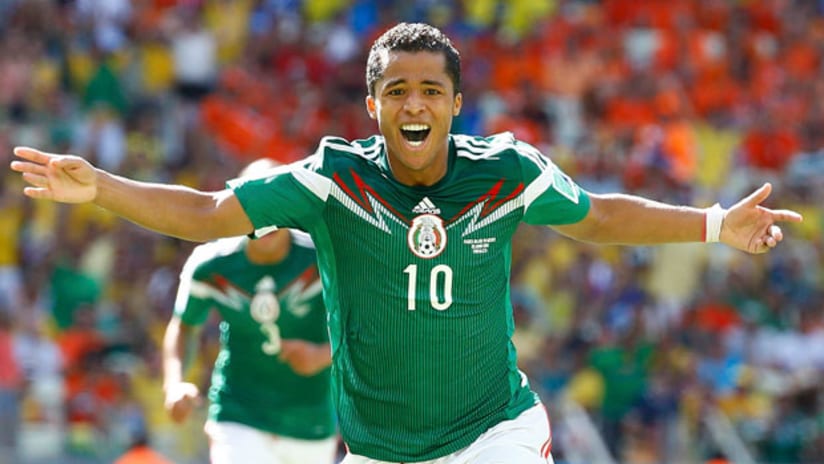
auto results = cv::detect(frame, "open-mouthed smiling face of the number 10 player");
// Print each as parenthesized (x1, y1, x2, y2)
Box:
(366, 52, 462, 185)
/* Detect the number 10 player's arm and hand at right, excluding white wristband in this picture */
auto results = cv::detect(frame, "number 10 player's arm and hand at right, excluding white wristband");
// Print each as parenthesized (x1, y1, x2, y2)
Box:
(554, 184, 802, 253)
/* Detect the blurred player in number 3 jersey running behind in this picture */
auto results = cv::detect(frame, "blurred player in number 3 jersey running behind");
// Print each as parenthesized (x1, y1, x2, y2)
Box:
(163, 159, 337, 464)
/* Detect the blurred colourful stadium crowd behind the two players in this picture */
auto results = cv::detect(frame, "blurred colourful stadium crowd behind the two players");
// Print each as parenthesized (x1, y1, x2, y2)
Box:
(0, 0, 824, 464)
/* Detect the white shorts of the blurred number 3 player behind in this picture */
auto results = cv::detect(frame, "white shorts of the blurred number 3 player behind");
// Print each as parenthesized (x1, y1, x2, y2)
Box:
(203, 421, 338, 464)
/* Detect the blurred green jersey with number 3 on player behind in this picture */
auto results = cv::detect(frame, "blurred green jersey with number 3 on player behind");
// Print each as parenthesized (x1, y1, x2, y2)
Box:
(174, 234, 336, 440)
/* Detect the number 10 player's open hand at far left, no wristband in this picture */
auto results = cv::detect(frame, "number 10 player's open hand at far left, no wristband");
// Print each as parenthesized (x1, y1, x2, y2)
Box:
(11, 147, 97, 203)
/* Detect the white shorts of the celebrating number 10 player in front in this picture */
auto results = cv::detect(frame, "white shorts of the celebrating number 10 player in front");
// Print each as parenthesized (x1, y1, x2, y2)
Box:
(341, 404, 553, 464)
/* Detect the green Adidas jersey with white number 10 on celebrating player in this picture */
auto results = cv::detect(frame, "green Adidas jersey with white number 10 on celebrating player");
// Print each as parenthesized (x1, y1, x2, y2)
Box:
(229, 133, 589, 461)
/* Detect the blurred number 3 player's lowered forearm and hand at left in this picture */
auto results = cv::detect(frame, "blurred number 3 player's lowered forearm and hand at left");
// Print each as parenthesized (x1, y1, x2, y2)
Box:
(163, 315, 202, 423)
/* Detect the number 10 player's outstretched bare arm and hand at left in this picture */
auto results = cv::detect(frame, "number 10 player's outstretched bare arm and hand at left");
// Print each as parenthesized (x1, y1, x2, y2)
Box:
(11, 147, 254, 242)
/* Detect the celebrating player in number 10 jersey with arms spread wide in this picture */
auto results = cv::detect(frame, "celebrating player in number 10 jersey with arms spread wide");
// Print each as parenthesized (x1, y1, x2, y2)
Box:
(11, 23, 801, 464)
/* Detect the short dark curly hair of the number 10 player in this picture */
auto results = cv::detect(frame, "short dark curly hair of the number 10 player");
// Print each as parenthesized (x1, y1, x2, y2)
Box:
(366, 23, 461, 96)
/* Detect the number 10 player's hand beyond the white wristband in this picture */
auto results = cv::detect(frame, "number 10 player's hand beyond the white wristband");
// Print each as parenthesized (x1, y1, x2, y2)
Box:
(720, 183, 803, 253)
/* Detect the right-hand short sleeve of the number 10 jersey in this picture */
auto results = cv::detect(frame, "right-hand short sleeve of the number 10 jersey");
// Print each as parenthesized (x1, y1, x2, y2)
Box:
(515, 141, 590, 225)
